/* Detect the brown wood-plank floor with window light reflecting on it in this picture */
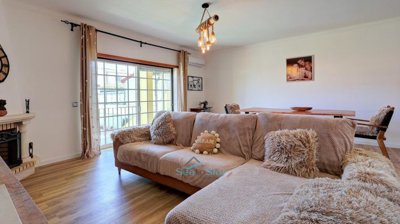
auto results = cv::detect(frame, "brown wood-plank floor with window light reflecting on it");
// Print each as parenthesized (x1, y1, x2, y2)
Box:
(22, 146, 400, 224)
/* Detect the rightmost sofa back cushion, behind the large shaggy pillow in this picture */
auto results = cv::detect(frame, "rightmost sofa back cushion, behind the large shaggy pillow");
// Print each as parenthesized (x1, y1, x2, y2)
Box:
(252, 113, 356, 175)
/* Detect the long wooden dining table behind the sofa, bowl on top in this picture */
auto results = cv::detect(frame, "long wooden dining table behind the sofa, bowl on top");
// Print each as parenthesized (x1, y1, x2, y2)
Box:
(240, 107, 356, 118)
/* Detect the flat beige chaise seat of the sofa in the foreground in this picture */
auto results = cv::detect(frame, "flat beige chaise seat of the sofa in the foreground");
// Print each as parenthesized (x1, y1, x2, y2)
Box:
(165, 160, 307, 224)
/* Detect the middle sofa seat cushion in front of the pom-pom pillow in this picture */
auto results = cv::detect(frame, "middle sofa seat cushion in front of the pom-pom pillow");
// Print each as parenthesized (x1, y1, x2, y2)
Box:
(159, 148, 246, 188)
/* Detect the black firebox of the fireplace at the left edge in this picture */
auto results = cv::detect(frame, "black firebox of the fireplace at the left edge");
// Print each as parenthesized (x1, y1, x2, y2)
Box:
(0, 128, 22, 168)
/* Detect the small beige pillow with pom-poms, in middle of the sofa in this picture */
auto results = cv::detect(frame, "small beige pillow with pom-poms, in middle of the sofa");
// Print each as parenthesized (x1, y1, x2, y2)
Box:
(192, 131, 221, 155)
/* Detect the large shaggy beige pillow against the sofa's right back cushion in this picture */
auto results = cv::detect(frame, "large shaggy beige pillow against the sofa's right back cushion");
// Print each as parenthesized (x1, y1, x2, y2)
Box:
(262, 129, 318, 178)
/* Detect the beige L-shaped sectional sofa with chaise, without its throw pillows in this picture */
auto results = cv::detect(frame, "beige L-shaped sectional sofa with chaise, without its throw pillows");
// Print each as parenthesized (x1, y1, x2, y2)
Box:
(113, 112, 355, 223)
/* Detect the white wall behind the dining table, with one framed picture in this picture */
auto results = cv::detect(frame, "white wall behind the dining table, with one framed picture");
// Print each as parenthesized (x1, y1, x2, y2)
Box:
(206, 18, 400, 147)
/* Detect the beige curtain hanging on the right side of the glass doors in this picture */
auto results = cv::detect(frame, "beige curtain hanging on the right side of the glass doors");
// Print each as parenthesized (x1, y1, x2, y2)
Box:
(177, 51, 189, 111)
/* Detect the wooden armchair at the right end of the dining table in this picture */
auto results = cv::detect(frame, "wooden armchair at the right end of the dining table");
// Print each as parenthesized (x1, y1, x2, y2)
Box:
(348, 106, 394, 158)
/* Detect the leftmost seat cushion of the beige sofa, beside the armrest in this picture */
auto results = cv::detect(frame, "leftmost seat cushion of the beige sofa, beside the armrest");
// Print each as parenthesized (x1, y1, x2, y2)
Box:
(117, 142, 182, 173)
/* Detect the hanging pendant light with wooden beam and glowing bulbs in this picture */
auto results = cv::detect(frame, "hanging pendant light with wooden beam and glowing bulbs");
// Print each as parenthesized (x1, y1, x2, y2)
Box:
(196, 3, 219, 54)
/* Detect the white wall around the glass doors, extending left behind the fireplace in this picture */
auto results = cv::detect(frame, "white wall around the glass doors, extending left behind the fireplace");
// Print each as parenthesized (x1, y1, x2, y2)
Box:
(0, 0, 203, 164)
